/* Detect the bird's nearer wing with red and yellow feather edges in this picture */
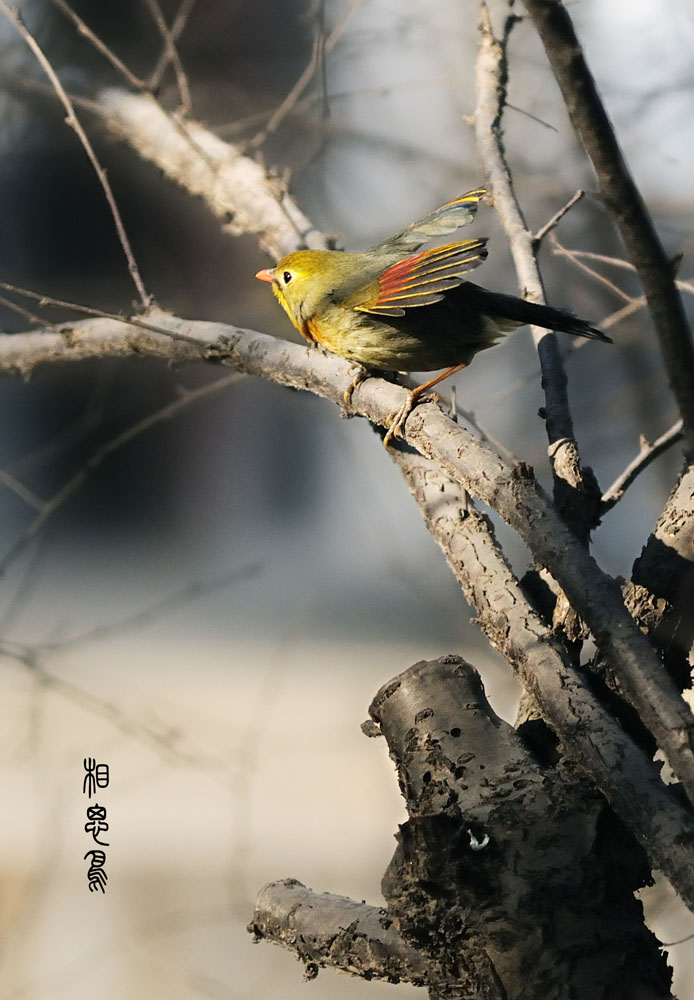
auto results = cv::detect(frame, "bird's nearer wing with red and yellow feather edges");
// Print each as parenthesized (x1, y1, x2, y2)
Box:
(341, 240, 487, 316)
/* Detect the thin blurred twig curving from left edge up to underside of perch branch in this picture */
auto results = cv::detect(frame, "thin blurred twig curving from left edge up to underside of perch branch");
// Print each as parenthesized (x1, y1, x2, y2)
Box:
(0, 372, 242, 576)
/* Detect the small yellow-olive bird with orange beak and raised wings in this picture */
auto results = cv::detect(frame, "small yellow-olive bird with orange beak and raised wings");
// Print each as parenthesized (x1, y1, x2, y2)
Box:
(256, 188, 611, 446)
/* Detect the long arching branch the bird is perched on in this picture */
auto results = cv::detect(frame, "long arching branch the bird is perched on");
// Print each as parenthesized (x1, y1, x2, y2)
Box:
(0, 313, 694, 800)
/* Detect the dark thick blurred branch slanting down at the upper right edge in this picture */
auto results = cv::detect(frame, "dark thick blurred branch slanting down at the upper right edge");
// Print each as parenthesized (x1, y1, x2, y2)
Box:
(524, 0, 694, 456)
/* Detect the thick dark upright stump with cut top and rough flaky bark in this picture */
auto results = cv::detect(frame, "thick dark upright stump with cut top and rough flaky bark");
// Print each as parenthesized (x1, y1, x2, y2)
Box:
(370, 657, 670, 1000)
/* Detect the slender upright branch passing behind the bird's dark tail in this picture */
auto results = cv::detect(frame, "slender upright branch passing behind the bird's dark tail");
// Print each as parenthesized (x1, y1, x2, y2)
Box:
(474, 0, 598, 544)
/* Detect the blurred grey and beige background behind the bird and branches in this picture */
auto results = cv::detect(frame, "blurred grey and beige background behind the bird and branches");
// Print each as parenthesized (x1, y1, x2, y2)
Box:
(0, 0, 694, 1000)
